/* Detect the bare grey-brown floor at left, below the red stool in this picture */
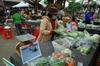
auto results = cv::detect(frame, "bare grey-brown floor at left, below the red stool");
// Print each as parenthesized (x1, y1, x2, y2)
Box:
(0, 31, 18, 66)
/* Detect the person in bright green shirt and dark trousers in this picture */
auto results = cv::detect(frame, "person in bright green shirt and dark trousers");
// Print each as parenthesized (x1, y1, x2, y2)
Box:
(12, 10, 24, 35)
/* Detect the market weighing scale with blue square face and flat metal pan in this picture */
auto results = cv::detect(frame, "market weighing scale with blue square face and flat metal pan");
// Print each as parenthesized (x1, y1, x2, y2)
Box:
(15, 34, 42, 64)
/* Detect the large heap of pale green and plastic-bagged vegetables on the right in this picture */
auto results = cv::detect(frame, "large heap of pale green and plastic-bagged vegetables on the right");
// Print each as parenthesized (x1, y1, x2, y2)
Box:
(52, 31, 100, 55)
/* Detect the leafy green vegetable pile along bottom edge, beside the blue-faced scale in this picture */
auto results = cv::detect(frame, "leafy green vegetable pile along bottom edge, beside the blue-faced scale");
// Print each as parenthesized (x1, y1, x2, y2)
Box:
(29, 57, 65, 66)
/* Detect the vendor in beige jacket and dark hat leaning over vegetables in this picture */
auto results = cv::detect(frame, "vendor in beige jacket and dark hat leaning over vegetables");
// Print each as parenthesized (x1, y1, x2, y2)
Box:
(37, 7, 58, 43)
